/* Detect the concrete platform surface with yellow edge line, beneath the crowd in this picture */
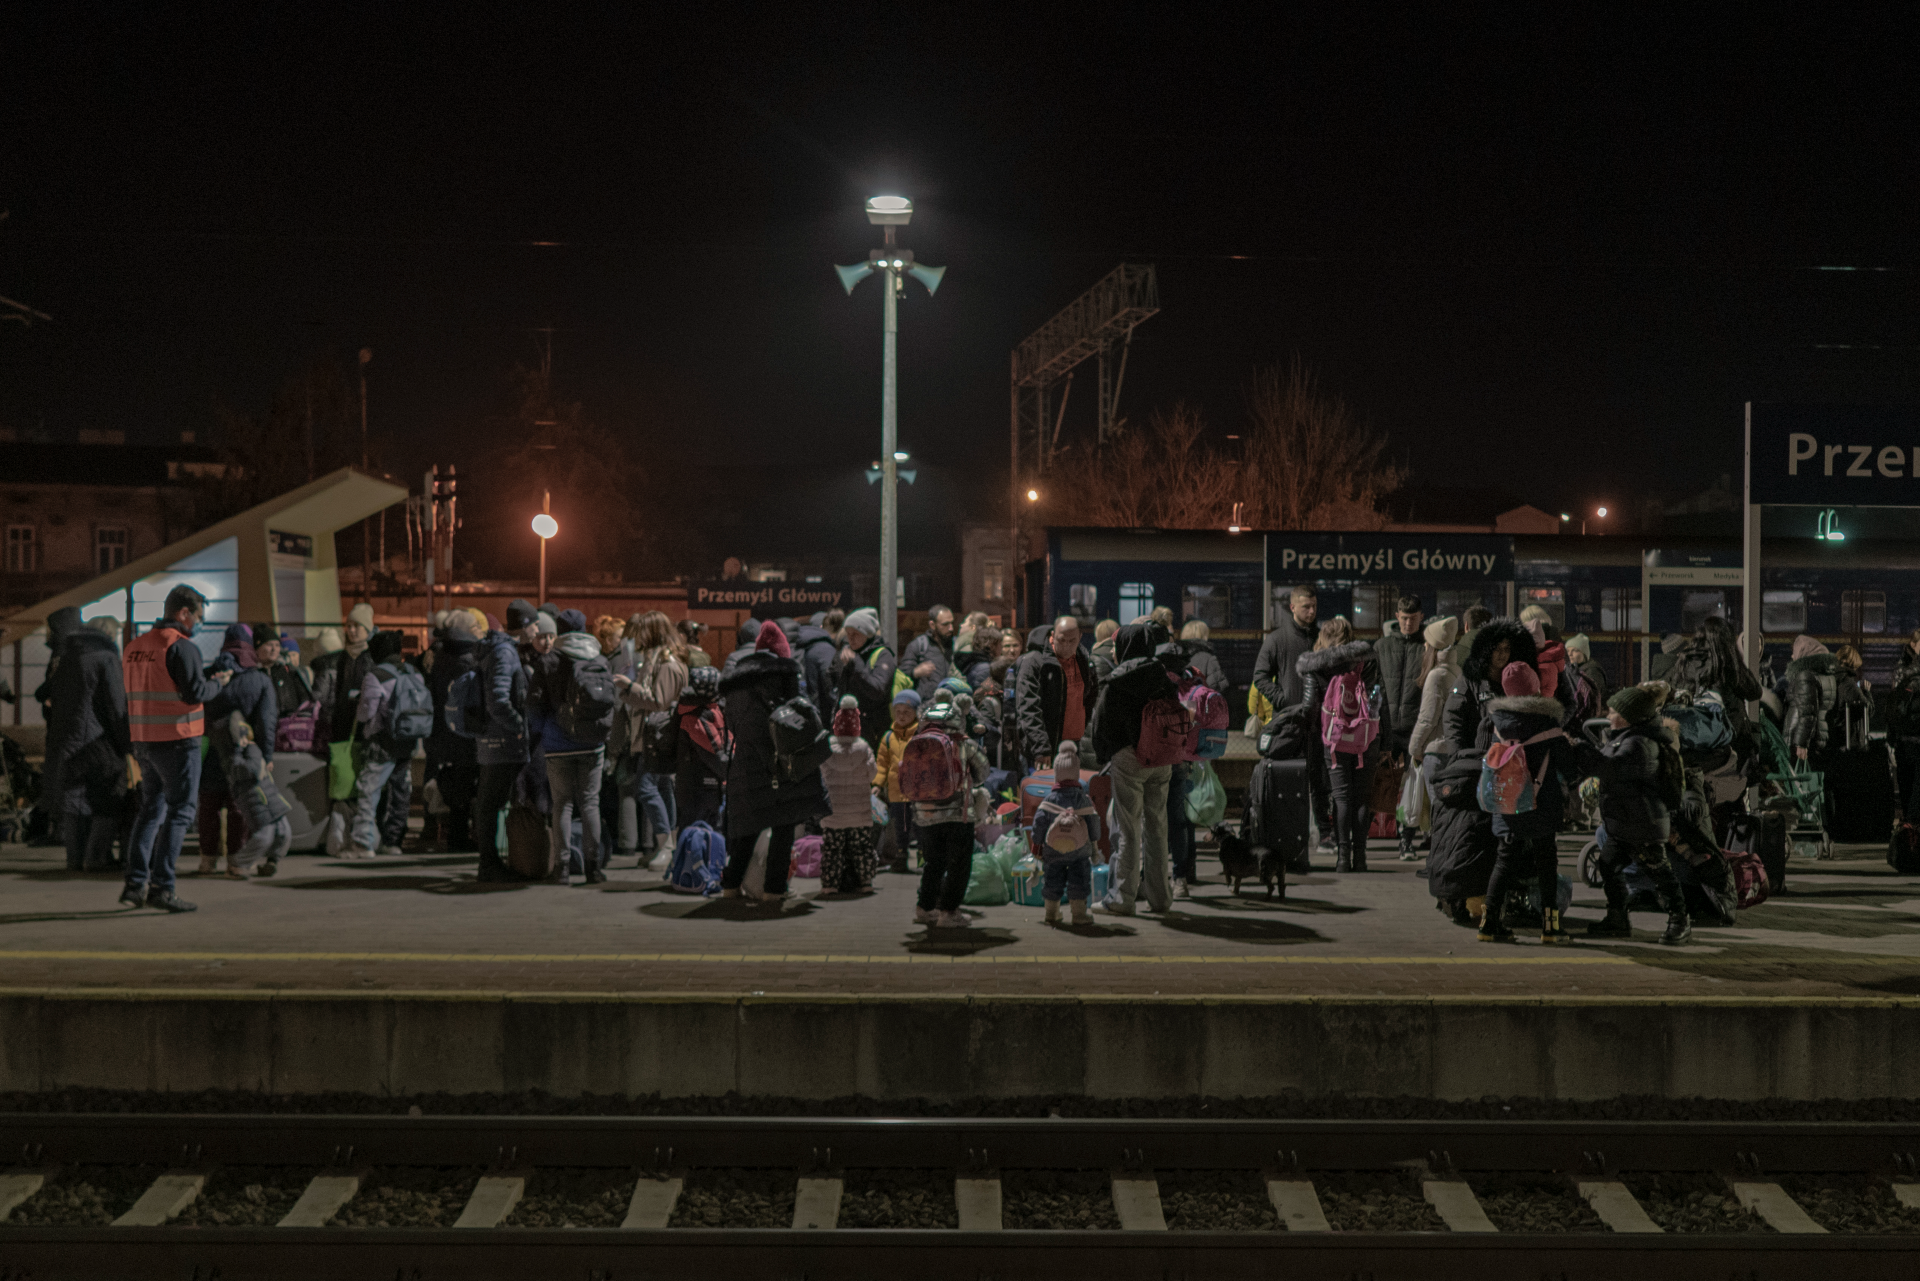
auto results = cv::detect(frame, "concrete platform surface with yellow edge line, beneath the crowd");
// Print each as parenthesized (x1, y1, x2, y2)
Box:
(0, 841, 1920, 1003)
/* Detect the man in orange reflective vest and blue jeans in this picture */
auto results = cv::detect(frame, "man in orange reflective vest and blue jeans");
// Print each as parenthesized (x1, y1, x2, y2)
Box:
(121, 584, 230, 912)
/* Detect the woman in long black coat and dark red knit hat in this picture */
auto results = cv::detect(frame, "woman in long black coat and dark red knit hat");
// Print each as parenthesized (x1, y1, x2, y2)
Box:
(720, 620, 828, 899)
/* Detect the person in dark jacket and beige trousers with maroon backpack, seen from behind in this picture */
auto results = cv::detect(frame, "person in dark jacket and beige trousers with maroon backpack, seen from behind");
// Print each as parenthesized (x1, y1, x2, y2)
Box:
(1090, 618, 1185, 916)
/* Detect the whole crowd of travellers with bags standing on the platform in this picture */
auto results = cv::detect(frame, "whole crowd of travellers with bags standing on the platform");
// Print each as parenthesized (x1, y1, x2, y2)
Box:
(38, 586, 1920, 941)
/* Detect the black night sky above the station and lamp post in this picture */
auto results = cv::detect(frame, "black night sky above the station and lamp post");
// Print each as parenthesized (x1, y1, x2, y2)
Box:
(0, 4, 1920, 541)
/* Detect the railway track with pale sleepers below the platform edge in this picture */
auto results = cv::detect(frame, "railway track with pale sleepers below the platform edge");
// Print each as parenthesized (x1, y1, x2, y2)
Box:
(0, 1114, 1920, 1281)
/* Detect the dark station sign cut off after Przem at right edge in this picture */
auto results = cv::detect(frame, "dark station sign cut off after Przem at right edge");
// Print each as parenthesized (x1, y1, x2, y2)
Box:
(1747, 405, 1920, 507)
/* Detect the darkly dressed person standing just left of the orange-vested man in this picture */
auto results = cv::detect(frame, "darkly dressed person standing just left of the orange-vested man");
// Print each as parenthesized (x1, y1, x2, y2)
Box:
(40, 611, 132, 872)
